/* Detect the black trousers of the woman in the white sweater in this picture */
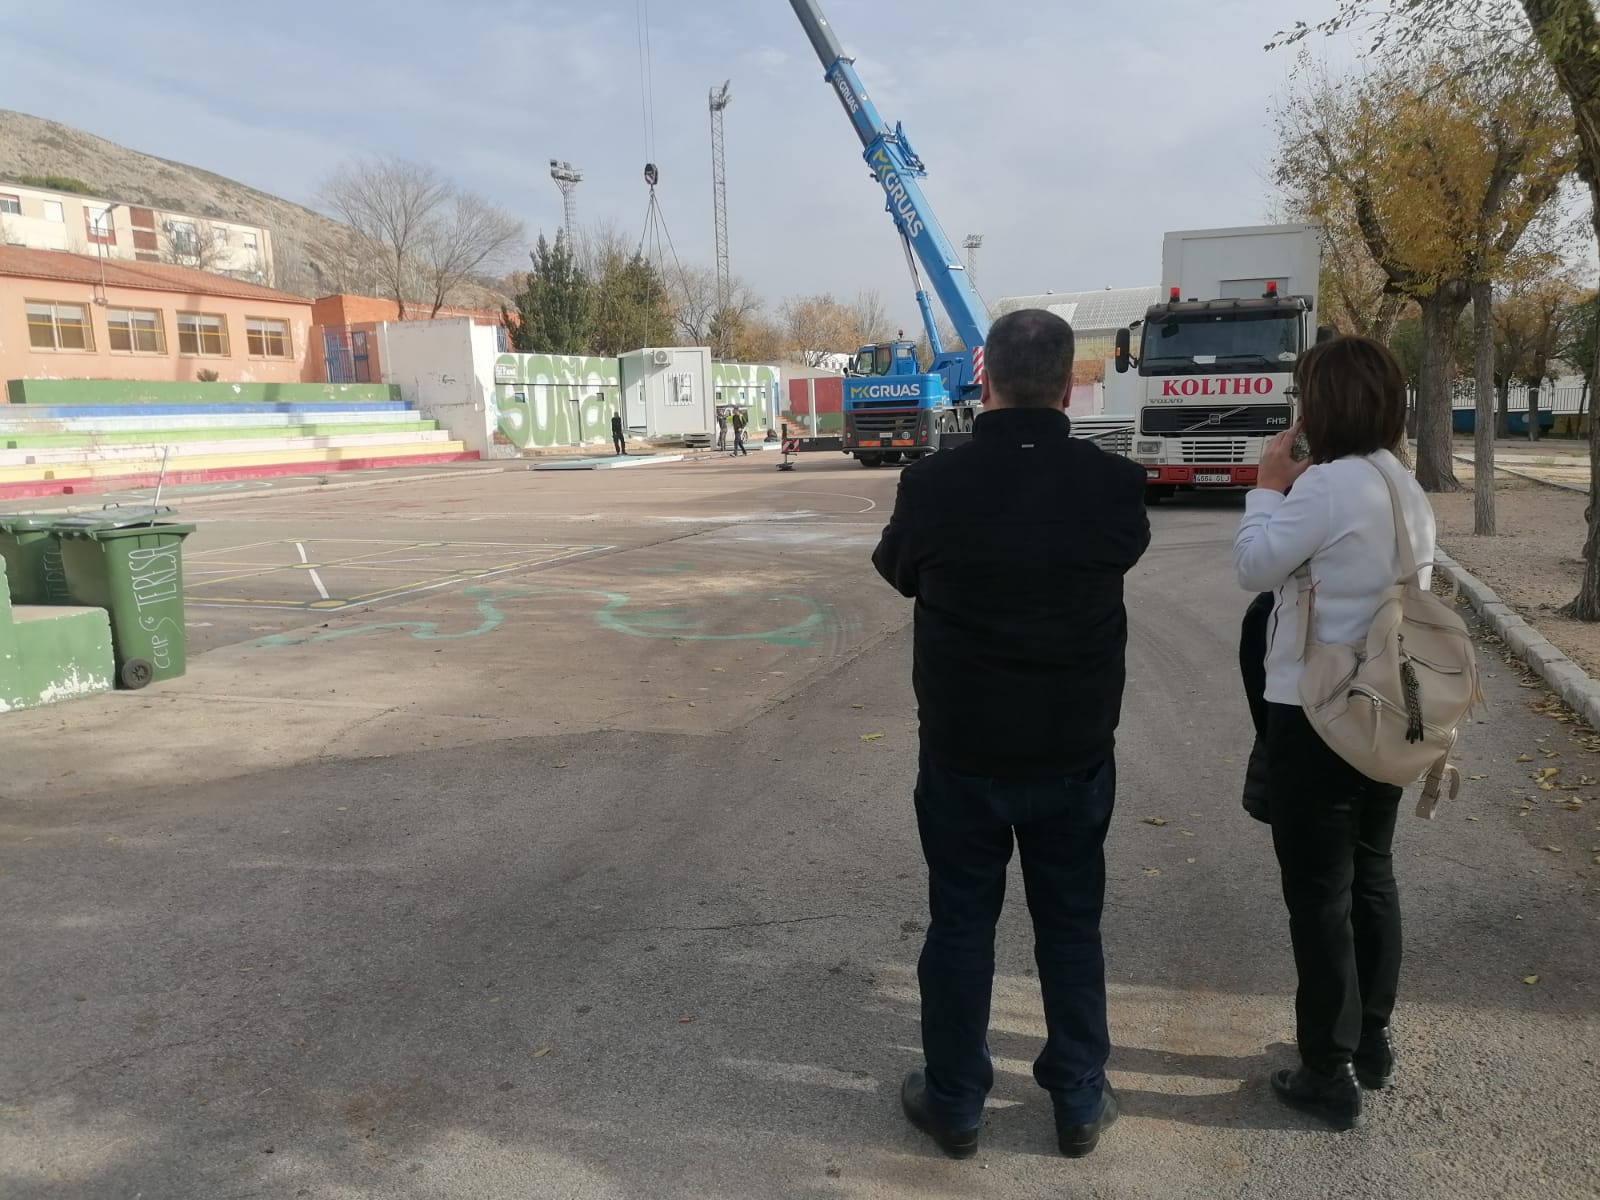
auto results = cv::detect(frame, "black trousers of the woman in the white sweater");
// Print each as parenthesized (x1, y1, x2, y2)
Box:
(1267, 704, 1402, 1072)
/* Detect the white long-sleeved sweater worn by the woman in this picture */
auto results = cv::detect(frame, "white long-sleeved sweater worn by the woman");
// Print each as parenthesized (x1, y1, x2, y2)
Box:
(1234, 450, 1434, 704)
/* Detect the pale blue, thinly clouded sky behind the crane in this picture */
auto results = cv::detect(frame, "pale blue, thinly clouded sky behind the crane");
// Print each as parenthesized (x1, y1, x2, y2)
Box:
(0, 0, 1350, 328)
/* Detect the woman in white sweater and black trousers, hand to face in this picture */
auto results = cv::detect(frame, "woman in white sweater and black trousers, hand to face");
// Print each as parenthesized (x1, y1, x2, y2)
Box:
(1234, 338, 1434, 1128)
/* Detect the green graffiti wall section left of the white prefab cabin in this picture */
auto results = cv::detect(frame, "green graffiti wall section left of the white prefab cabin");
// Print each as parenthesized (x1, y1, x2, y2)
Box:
(494, 354, 622, 450)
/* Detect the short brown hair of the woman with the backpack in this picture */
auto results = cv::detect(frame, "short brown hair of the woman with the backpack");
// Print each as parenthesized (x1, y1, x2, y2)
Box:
(1294, 338, 1406, 462)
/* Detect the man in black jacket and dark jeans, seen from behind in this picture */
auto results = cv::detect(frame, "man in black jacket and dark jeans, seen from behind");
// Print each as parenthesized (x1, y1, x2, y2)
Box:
(872, 309, 1150, 1157)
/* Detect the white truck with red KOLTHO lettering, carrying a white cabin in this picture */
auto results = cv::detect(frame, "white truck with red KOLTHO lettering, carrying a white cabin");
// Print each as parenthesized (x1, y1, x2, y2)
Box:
(1106, 224, 1322, 502)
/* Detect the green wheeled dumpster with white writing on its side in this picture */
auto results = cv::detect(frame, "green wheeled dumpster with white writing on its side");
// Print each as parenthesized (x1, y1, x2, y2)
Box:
(51, 507, 195, 688)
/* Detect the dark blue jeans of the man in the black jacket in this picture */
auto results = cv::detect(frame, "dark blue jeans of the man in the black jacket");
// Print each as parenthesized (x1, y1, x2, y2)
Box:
(917, 755, 1117, 1130)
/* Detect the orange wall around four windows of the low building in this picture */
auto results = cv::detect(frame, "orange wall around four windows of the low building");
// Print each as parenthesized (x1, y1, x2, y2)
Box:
(0, 277, 318, 385)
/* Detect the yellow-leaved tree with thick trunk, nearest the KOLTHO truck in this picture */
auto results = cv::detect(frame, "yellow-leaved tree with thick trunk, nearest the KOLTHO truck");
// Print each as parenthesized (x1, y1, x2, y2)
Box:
(1275, 46, 1571, 491)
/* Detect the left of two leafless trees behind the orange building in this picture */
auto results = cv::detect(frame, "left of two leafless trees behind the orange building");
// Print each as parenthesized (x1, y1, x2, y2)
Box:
(322, 158, 453, 320)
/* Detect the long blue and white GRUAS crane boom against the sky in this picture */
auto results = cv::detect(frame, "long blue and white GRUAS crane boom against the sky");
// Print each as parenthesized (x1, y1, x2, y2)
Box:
(789, 0, 989, 364)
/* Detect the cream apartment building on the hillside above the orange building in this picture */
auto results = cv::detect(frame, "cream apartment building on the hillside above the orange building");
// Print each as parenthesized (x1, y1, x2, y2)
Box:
(0, 179, 272, 285)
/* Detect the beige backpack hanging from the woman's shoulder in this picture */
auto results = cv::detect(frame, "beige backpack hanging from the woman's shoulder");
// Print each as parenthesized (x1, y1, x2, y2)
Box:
(1294, 464, 1483, 819)
